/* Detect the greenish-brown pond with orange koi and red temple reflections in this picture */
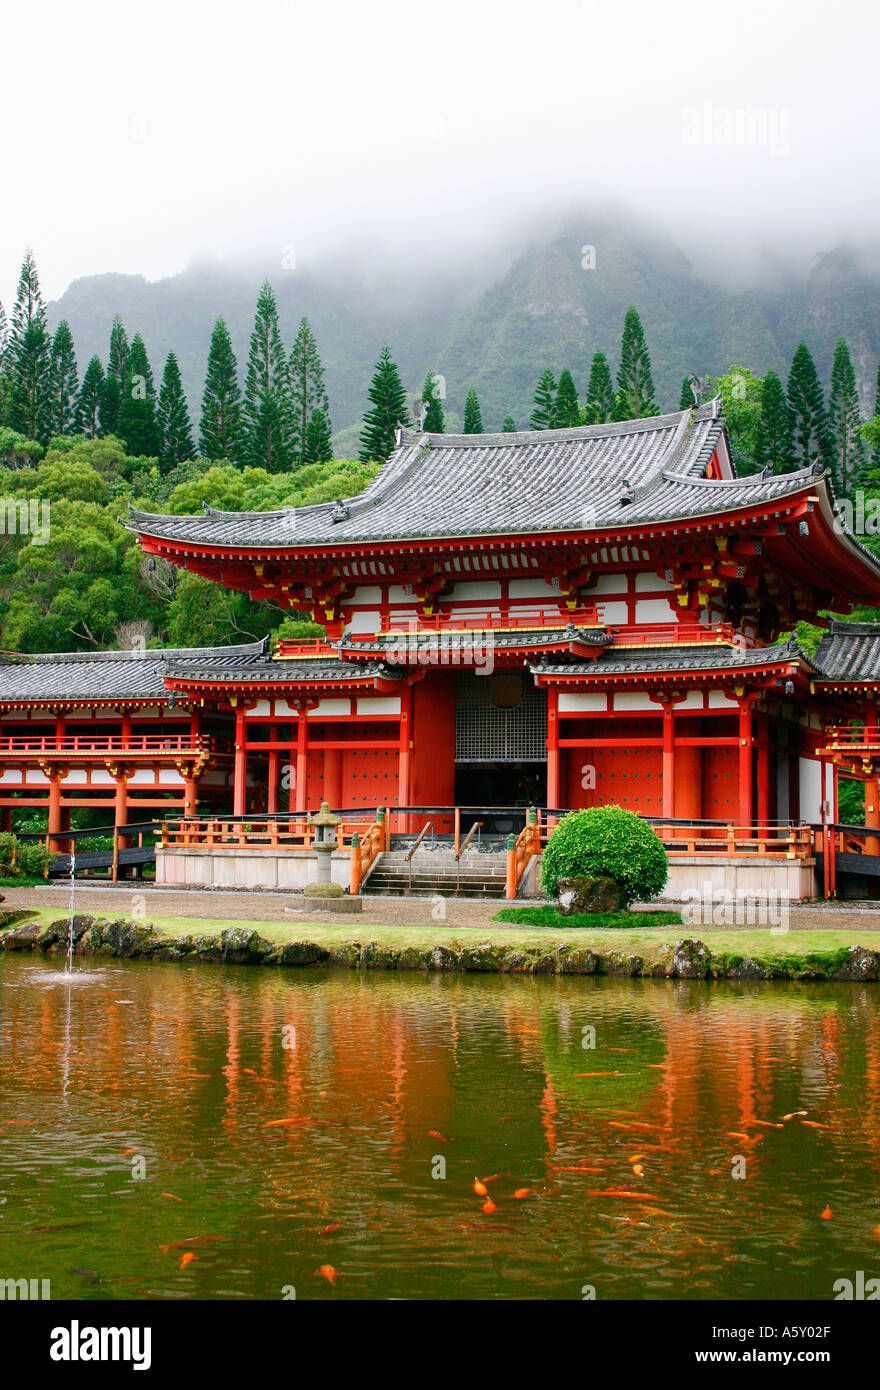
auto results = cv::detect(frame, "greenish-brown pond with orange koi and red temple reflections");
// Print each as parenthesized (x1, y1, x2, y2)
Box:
(0, 956, 880, 1300)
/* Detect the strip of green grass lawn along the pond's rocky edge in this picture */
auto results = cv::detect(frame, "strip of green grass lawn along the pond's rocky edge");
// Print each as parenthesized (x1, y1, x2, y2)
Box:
(13, 908, 872, 962)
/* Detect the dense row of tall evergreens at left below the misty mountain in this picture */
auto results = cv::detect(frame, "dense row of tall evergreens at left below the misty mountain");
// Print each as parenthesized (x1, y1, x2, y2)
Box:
(0, 252, 332, 473)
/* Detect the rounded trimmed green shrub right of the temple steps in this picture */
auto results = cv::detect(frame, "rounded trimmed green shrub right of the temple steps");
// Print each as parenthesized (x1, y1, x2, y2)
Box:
(541, 806, 669, 905)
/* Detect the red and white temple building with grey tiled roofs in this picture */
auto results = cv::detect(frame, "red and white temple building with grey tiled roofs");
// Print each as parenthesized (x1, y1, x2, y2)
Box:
(0, 400, 880, 895)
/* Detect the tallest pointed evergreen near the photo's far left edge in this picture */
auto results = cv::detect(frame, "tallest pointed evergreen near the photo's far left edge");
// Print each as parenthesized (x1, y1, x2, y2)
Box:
(7, 250, 51, 443)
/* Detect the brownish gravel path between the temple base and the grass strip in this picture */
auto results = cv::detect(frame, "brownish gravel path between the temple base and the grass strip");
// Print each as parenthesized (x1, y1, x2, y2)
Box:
(3, 883, 880, 935)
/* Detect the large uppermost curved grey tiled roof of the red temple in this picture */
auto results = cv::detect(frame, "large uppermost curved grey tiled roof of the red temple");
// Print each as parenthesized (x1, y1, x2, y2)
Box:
(128, 402, 815, 549)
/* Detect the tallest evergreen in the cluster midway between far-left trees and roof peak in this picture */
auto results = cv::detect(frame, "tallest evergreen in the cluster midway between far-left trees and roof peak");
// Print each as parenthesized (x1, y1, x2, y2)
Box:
(242, 281, 291, 473)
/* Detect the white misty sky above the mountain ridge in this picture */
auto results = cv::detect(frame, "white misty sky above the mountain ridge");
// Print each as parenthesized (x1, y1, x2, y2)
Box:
(0, 0, 880, 311)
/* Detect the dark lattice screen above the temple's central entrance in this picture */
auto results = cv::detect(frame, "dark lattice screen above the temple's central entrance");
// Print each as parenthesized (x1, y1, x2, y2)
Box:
(455, 673, 546, 763)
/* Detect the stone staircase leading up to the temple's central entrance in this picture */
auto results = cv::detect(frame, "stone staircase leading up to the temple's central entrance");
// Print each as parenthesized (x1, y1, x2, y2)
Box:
(361, 847, 507, 898)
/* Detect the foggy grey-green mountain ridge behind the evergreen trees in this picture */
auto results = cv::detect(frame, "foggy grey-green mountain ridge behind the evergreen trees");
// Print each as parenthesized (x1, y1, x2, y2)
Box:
(49, 205, 880, 455)
